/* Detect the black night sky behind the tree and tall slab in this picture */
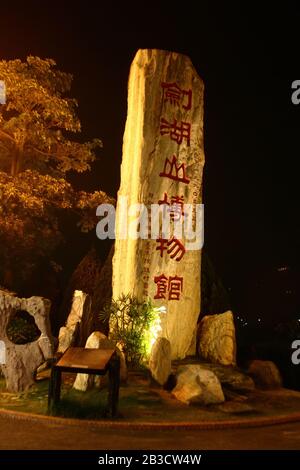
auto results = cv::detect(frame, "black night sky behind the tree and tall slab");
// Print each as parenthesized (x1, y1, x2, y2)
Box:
(0, 0, 300, 324)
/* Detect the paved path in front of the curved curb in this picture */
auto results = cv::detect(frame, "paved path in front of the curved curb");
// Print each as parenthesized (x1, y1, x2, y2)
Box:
(0, 416, 300, 450)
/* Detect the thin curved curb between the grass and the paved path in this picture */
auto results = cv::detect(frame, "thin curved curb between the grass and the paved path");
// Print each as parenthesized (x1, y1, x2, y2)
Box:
(0, 408, 300, 431)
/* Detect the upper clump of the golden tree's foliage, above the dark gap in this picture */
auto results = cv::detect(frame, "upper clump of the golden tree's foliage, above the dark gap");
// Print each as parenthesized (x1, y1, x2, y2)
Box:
(0, 56, 102, 175)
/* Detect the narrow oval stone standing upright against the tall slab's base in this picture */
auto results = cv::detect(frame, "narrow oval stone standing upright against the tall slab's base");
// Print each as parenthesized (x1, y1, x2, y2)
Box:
(149, 338, 171, 385)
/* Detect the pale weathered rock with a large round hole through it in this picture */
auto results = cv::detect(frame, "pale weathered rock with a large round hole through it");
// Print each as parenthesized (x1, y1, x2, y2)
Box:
(0, 292, 53, 392)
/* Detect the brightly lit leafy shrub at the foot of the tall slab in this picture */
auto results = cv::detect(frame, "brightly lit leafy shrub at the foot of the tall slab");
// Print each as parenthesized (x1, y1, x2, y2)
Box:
(100, 294, 157, 366)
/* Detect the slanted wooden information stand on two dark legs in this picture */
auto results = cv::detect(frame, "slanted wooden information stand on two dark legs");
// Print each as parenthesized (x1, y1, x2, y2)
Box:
(48, 347, 120, 418)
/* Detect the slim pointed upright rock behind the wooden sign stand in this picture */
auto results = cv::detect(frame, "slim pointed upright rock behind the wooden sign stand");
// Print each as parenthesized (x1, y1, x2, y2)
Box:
(58, 290, 93, 353)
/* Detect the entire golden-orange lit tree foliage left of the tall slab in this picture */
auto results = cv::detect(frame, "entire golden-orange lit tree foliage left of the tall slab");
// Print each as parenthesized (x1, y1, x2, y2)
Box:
(0, 56, 114, 287)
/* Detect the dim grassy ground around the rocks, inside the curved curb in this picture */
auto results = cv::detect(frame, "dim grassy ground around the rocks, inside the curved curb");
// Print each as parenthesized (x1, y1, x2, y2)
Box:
(0, 374, 300, 423)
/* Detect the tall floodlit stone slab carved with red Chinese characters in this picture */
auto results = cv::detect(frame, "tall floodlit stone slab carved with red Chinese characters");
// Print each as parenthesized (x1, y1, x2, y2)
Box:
(113, 50, 204, 359)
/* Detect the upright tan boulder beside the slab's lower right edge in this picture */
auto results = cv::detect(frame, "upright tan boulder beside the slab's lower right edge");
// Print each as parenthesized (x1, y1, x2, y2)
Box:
(198, 310, 236, 365)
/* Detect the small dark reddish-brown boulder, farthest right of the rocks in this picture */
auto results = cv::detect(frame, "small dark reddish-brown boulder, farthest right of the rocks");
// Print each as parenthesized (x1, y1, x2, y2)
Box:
(247, 360, 282, 390)
